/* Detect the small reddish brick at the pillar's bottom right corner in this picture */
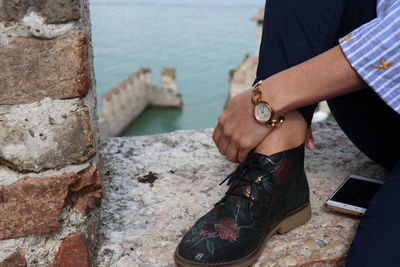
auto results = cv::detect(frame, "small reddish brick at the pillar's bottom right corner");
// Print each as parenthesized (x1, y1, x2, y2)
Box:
(49, 233, 92, 267)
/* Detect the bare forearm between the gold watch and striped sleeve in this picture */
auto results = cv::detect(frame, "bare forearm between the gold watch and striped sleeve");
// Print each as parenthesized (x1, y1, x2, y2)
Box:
(261, 46, 366, 114)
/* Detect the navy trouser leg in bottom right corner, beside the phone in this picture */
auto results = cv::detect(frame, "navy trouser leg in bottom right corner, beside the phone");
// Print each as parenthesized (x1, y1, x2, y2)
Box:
(346, 161, 400, 267)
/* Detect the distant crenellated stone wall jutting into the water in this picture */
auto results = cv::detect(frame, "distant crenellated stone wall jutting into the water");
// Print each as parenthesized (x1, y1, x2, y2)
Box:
(100, 68, 183, 138)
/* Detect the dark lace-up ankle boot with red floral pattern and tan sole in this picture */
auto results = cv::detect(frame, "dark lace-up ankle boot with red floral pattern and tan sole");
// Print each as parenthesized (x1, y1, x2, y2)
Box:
(175, 145, 311, 267)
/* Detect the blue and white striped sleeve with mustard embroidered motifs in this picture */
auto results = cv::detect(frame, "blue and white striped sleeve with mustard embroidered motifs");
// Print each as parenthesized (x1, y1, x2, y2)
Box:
(339, 0, 400, 114)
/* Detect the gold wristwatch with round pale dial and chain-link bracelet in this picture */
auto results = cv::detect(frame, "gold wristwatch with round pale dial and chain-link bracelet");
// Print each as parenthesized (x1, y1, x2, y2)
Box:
(251, 80, 285, 127)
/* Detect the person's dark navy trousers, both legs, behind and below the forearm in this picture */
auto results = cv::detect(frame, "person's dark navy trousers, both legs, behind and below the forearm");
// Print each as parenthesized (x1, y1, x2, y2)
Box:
(256, 0, 400, 267)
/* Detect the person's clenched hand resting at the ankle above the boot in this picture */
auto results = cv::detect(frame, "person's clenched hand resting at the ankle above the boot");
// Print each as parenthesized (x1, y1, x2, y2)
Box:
(212, 90, 271, 162)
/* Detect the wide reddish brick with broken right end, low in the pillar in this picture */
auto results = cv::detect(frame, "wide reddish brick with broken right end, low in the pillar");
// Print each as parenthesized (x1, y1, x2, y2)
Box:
(0, 167, 102, 240)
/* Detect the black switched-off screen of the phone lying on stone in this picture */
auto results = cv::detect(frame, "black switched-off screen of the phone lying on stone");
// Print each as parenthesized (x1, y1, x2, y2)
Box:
(331, 177, 381, 209)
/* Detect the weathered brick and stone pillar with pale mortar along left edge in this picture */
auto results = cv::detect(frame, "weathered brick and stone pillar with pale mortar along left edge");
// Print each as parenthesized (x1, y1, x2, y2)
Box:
(0, 0, 102, 267)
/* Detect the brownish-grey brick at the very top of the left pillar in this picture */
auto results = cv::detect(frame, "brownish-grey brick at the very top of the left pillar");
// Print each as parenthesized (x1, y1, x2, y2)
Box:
(0, 0, 80, 23)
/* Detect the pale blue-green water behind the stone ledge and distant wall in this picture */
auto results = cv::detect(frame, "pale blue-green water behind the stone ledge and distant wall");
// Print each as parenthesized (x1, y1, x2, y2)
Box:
(90, 0, 265, 135)
